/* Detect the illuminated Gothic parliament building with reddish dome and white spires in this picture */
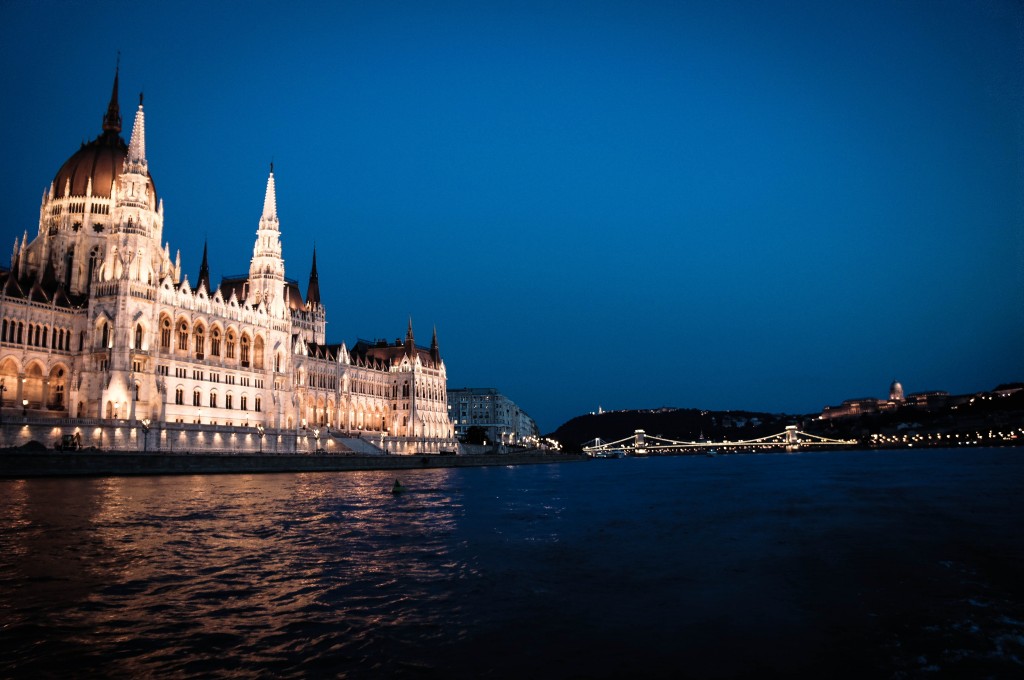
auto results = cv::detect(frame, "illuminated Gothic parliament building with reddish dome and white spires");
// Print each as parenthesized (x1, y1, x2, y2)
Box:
(0, 69, 457, 453)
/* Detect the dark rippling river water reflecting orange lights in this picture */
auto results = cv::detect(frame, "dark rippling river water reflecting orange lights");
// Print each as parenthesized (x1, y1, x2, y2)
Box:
(0, 449, 1024, 678)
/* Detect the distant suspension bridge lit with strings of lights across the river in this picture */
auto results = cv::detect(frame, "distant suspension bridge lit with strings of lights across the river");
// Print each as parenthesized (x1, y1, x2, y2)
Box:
(583, 425, 857, 458)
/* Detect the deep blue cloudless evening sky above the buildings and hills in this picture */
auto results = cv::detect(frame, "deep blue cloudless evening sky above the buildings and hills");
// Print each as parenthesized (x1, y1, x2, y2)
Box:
(0, 0, 1024, 431)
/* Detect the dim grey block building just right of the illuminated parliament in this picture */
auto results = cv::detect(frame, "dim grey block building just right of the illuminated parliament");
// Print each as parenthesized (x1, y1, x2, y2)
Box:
(447, 387, 541, 444)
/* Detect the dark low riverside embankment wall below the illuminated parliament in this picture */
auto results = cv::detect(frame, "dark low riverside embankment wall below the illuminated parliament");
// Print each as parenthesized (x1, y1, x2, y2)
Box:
(0, 449, 584, 478)
